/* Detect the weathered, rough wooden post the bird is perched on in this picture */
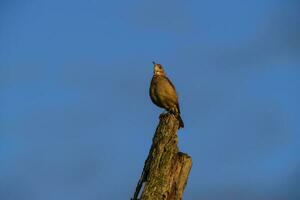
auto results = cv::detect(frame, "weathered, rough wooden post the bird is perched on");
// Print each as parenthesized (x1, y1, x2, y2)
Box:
(132, 114, 192, 200)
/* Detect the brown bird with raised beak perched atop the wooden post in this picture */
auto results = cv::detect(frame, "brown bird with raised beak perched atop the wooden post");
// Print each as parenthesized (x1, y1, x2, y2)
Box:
(149, 62, 184, 128)
